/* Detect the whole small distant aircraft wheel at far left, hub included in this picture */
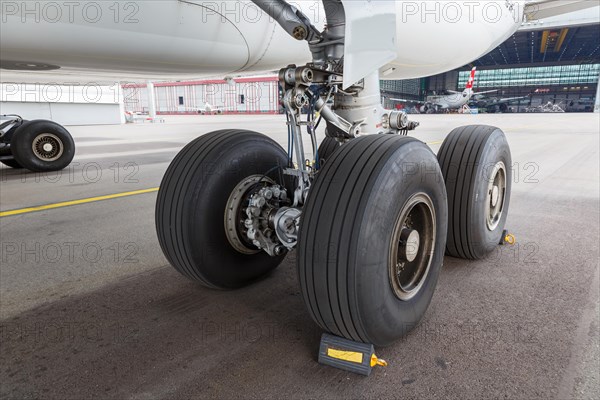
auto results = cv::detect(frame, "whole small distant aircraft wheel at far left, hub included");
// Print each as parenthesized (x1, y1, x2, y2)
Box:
(10, 119, 75, 172)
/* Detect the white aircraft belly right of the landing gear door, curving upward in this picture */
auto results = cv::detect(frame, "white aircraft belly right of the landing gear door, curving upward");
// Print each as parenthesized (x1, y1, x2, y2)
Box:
(381, 0, 524, 79)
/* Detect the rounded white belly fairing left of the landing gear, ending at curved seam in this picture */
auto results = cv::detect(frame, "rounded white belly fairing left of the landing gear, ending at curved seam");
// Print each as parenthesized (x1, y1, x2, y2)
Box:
(0, 1, 250, 74)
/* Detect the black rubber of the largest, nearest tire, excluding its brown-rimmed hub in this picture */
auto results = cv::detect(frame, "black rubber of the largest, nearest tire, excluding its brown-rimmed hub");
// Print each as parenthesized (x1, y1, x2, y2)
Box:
(297, 135, 447, 346)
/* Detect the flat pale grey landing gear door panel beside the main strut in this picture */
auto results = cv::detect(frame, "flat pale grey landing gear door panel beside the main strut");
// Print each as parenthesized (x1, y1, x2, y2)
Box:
(342, 0, 397, 89)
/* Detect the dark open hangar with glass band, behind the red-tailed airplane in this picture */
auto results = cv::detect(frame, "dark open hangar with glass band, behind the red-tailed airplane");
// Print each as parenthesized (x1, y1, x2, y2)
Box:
(382, 18, 600, 112)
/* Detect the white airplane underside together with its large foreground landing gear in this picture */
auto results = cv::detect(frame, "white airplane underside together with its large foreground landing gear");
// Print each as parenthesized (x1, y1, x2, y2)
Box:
(0, 0, 588, 345)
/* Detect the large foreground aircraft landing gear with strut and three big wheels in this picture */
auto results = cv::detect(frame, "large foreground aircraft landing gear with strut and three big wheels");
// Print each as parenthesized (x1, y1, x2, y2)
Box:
(156, 0, 510, 346)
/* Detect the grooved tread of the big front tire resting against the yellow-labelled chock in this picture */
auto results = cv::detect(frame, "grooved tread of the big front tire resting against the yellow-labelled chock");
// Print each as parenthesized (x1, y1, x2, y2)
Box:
(298, 135, 416, 342)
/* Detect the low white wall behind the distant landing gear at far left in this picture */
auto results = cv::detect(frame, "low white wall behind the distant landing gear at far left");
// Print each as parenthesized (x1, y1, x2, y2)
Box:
(0, 83, 125, 125)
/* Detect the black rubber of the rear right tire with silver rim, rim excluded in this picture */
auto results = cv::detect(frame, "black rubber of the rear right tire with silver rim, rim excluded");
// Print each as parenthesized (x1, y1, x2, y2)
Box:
(438, 125, 512, 260)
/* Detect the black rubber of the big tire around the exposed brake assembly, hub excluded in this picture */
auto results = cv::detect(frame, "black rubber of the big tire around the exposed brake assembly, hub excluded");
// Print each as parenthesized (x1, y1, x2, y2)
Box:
(156, 130, 289, 289)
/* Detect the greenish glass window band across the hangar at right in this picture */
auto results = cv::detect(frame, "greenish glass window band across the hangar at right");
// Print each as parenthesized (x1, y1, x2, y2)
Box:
(458, 64, 600, 88)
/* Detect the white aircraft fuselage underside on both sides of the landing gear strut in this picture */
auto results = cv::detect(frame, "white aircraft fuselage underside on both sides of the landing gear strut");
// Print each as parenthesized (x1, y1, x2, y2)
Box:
(0, 0, 524, 83)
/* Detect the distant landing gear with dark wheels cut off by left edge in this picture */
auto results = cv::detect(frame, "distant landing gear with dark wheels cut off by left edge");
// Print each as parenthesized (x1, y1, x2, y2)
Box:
(0, 115, 75, 172)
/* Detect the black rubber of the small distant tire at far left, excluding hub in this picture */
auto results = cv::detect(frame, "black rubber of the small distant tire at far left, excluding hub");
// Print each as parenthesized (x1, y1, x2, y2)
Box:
(10, 119, 75, 172)
